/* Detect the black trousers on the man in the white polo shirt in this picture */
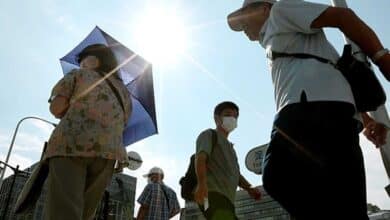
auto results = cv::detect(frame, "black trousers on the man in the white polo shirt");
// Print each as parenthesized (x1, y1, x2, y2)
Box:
(263, 102, 368, 220)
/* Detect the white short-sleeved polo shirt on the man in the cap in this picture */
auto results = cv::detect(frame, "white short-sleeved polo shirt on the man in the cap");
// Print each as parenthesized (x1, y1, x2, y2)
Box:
(259, 0, 355, 111)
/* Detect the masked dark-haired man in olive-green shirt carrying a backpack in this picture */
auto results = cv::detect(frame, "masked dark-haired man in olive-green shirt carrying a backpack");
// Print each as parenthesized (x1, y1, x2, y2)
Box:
(194, 101, 261, 220)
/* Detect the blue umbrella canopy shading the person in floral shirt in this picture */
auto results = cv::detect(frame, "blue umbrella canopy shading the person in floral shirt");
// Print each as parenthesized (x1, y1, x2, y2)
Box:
(60, 26, 158, 146)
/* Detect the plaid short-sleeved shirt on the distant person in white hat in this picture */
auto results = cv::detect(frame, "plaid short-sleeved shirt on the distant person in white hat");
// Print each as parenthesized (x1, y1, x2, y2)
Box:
(137, 183, 180, 220)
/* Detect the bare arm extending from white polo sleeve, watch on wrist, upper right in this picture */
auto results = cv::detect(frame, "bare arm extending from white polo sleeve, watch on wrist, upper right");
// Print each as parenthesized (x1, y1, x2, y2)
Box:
(311, 7, 390, 81)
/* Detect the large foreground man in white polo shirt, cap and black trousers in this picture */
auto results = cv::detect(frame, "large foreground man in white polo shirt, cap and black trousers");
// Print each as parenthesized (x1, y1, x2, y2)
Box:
(228, 0, 390, 220)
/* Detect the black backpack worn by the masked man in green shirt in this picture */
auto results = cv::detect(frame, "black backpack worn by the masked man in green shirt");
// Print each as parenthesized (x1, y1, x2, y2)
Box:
(179, 129, 217, 201)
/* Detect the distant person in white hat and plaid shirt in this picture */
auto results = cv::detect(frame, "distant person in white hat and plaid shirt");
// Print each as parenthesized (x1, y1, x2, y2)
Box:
(137, 167, 180, 220)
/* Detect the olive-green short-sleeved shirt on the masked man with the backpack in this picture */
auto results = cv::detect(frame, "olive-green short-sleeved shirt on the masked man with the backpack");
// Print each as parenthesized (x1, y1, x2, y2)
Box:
(196, 129, 240, 204)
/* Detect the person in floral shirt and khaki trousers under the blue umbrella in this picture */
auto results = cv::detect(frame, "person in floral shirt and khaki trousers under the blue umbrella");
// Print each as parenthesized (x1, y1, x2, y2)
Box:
(44, 44, 132, 220)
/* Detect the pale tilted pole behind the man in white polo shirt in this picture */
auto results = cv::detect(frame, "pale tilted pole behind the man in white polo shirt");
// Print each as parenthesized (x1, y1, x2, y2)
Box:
(332, 0, 390, 197)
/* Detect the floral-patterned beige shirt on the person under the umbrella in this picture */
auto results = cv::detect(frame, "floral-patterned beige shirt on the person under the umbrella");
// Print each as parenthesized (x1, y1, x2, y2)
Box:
(45, 69, 131, 162)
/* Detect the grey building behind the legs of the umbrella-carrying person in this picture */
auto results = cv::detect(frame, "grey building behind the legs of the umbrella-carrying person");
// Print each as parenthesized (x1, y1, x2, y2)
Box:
(0, 165, 137, 220)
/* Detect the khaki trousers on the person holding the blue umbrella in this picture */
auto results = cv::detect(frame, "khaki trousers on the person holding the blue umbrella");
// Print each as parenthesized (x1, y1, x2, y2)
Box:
(44, 157, 115, 220)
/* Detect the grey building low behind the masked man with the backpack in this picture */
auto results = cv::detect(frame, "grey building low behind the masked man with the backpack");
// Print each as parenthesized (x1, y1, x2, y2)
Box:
(180, 186, 292, 220)
